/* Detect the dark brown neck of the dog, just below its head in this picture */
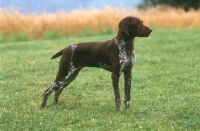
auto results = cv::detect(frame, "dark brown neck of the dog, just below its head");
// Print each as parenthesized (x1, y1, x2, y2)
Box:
(115, 31, 135, 51)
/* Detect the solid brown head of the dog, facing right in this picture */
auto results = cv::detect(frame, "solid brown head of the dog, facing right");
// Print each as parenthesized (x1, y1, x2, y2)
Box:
(118, 16, 152, 37)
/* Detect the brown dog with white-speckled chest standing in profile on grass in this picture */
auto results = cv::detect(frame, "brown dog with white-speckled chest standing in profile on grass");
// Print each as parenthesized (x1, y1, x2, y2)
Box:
(41, 16, 152, 111)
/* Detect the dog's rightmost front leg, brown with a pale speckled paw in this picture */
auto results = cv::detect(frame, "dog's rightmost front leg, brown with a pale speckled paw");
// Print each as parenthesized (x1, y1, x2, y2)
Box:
(124, 69, 132, 109)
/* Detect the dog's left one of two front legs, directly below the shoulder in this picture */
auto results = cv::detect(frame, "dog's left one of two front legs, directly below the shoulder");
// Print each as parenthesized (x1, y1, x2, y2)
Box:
(112, 73, 122, 111)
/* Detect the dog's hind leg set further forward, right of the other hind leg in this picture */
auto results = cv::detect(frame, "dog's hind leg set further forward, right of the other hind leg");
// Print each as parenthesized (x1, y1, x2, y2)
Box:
(54, 69, 81, 104)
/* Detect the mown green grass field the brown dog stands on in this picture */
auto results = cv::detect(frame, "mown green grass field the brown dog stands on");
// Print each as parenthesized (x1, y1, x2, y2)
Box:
(0, 29, 200, 131)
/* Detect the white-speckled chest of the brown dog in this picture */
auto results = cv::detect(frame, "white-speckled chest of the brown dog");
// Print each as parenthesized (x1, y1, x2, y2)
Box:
(117, 40, 136, 74)
